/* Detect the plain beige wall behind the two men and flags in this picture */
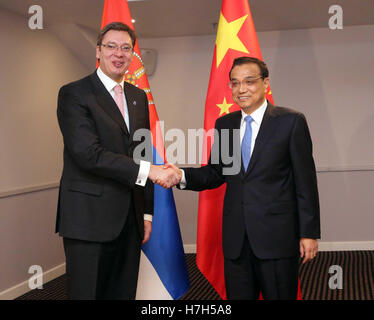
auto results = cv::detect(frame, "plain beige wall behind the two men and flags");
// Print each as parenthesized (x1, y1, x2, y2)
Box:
(0, 5, 374, 292)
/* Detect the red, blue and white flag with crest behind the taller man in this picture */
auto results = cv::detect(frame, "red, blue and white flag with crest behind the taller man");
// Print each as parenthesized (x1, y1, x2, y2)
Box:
(101, 0, 190, 300)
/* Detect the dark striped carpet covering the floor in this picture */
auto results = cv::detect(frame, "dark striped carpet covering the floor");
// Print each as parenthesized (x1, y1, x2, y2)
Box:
(17, 251, 374, 300)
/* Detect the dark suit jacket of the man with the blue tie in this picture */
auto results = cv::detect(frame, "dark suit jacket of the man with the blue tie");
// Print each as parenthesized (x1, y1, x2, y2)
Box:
(184, 102, 320, 259)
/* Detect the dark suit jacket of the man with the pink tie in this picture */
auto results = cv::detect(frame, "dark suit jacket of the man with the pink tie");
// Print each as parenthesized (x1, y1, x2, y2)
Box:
(56, 72, 153, 242)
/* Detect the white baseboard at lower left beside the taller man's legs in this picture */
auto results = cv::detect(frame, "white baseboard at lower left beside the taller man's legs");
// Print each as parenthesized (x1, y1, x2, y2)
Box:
(0, 263, 66, 300)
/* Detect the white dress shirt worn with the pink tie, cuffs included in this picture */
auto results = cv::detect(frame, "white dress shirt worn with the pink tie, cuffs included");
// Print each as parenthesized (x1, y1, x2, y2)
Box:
(96, 67, 152, 221)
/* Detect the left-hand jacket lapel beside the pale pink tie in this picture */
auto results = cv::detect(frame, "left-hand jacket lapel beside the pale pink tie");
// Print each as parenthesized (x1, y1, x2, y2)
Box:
(91, 71, 129, 136)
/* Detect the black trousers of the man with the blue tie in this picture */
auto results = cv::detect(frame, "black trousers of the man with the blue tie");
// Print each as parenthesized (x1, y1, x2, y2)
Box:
(224, 236, 299, 300)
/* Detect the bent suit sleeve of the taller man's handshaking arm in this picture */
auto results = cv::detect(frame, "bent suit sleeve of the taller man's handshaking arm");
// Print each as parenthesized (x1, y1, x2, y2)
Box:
(57, 86, 139, 187)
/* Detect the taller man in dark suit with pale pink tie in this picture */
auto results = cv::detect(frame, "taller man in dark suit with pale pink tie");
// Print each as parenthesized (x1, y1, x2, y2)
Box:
(56, 23, 177, 299)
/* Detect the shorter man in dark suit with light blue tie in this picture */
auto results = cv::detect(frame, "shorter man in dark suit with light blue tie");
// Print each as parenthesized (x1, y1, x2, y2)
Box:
(164, 57, 320, 299)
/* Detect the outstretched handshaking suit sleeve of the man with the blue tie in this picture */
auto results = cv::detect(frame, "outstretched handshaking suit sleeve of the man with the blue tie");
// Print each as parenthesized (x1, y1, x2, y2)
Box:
(183, 121, 225, 191)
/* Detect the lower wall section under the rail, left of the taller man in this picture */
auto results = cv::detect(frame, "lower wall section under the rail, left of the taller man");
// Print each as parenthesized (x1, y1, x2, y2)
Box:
(0, 189, 60, 292)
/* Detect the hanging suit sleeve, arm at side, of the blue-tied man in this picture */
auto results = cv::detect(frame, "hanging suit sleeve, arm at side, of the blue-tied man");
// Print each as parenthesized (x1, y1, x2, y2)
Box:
(290, 114, 320, 239)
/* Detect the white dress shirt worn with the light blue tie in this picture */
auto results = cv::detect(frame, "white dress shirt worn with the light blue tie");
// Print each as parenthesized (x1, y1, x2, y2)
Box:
(179, 99, 268, 189)
